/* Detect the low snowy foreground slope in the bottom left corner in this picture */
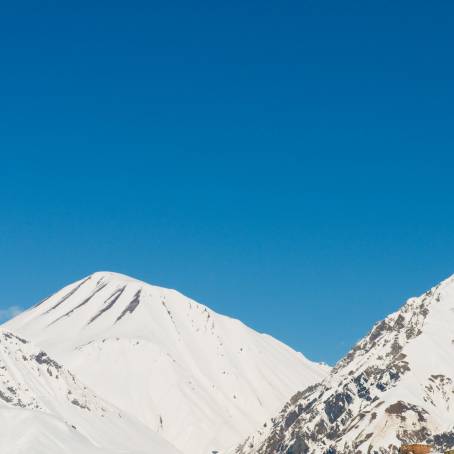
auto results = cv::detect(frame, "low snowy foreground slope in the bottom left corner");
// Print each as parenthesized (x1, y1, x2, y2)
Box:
(0, 331, 178, 454)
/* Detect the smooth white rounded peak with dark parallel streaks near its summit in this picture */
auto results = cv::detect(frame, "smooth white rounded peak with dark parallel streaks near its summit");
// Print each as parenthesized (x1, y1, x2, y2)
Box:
(6, 273, 329, 454)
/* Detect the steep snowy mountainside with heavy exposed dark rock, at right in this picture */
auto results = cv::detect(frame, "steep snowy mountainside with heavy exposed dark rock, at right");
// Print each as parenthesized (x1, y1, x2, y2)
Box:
(236, 277, 454, 454)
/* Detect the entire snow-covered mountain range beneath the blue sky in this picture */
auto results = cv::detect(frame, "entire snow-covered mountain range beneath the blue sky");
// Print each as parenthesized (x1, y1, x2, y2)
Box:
(0, 272, 454, 454)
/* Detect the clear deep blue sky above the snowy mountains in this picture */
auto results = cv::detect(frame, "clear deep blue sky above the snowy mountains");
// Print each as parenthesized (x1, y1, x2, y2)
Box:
(0, 0, 454, 363)
